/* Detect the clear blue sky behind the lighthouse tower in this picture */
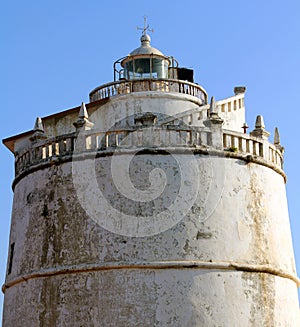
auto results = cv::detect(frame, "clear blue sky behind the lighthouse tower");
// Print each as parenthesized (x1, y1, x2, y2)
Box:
(0, 0, 300, 320)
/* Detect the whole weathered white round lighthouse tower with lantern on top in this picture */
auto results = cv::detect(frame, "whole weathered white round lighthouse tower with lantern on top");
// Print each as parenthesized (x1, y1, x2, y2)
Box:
(2, 24, 300, 327)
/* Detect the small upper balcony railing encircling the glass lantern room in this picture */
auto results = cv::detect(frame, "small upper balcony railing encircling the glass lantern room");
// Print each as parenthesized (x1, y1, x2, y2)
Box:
(90, 79, 207, 104)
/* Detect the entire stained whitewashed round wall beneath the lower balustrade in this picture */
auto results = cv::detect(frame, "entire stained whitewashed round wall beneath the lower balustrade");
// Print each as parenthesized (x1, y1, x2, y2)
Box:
(4, 153, 299, 327)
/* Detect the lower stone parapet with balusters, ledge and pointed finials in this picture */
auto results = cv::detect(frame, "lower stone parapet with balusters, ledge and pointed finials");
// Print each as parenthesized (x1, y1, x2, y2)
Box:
(3, 105, 285, 190)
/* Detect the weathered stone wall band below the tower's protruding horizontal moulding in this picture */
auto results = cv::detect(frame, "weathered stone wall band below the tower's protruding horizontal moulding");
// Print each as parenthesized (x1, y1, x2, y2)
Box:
(4, 268, 299, 327)
